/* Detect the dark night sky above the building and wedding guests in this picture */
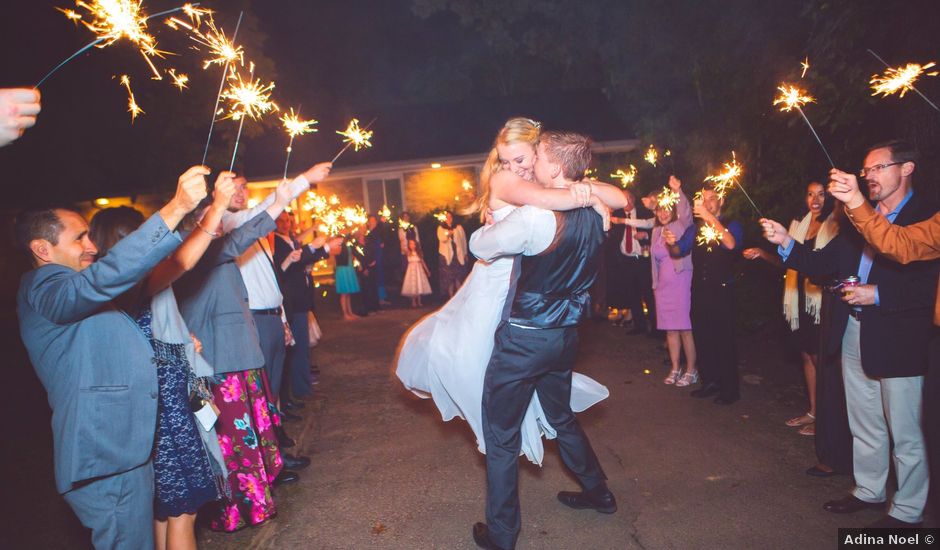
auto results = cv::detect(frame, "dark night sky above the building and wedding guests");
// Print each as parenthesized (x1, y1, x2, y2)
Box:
(0, 0, 940, 206)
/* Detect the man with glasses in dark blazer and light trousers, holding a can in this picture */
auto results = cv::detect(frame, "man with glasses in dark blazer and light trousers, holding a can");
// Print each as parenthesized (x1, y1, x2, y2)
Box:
(761, 141, 938, 527)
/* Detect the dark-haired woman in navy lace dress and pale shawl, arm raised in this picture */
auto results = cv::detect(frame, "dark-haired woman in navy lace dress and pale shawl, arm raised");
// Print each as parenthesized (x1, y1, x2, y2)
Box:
(89, 172, 235, 548)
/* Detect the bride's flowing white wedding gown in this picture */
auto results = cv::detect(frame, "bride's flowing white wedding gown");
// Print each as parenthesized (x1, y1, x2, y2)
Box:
(395, 205, 610, 465)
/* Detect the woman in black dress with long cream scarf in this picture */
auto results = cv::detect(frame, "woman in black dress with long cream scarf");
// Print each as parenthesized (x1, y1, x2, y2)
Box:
(742, 181, 839, 436)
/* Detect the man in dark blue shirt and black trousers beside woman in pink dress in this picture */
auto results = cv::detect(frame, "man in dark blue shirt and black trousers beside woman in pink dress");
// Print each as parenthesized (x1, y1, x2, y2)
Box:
(663, 186, 744, 405)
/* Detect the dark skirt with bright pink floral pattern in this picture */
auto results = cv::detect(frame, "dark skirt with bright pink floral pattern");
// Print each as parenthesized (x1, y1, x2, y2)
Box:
(210, 369, 283, 531)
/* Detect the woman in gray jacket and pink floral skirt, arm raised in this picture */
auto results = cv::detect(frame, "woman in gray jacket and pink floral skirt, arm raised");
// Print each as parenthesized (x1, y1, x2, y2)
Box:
(174, 179, 298, 531)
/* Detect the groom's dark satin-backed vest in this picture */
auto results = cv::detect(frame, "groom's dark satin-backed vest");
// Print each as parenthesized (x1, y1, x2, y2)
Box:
(509, 208, 604, 328)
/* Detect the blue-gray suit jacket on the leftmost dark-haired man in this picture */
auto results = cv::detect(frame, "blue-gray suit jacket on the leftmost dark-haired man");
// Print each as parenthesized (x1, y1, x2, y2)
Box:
(17, 214, 181, 493)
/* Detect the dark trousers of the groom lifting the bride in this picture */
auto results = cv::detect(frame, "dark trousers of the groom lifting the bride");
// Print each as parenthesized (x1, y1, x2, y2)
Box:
(483, 322, 607, 548)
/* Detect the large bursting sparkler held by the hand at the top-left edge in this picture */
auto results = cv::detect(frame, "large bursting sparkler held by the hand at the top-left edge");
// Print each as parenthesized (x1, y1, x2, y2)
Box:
(34, 0, 199, 88)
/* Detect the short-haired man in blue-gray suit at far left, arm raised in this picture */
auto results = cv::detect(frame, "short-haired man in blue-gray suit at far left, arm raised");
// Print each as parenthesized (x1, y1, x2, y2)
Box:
(16, 166, 209, 549)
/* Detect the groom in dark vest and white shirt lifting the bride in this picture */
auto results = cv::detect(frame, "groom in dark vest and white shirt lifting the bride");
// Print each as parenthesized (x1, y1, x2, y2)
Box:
(470, 132, 626, 549)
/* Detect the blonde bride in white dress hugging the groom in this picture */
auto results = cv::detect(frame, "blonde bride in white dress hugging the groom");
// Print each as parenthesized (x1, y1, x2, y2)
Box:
(396, 118, 622, 465)
